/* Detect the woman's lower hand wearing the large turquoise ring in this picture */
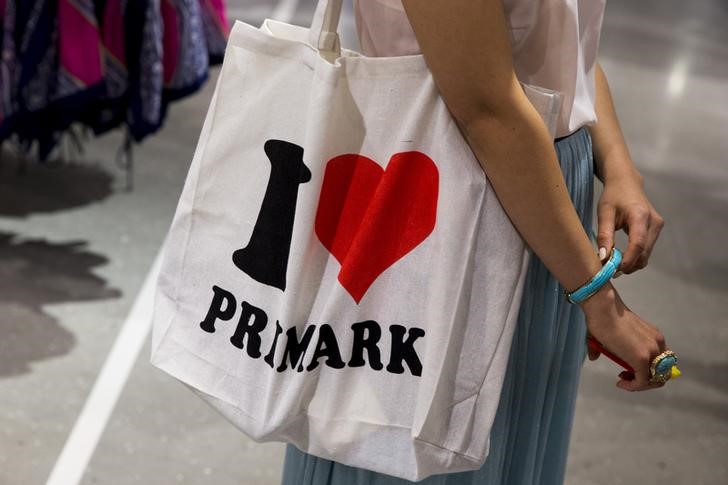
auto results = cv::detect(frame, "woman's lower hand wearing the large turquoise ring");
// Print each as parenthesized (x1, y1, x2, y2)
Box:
(581, 284, 666, 391)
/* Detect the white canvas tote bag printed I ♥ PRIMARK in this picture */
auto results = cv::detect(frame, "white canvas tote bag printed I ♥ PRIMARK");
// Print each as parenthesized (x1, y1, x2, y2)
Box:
(152, 0, 557, 480)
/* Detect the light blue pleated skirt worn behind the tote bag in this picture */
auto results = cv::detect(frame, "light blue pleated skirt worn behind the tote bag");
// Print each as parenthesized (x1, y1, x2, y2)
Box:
(283, 128, 594, 485)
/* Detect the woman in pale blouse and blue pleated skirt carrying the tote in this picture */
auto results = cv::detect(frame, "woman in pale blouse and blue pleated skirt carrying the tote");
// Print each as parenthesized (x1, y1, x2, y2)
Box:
(283, 0, 666, 485)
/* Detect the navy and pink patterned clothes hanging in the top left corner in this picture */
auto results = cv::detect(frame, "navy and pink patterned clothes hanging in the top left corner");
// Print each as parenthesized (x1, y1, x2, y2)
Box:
(0, 0, 229, 159)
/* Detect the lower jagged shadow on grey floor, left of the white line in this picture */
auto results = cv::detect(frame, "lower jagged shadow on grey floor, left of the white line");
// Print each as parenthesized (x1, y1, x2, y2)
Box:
(0, 232, 121, 378)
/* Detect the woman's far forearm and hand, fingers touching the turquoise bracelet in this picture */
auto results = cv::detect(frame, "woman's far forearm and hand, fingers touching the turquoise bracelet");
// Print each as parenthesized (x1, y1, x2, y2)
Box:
(589, 64, 665, 273)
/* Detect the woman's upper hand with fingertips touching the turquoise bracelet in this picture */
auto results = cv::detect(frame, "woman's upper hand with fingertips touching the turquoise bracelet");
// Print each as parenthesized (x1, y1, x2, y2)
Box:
(597, 170, 665, 274)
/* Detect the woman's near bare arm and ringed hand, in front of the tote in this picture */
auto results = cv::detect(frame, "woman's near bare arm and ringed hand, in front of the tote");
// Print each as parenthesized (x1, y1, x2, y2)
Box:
(403, 0, 665, 390)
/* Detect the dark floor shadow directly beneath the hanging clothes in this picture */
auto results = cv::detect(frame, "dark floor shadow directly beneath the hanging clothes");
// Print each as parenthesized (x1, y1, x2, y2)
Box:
(0, 150, 114, 217)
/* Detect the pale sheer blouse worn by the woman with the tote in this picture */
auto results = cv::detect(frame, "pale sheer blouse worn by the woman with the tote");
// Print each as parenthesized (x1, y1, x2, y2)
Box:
(354, 0, 606, 137)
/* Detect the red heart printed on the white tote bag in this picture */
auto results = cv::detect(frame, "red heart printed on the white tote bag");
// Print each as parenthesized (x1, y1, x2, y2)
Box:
(315, 151, 439, 303)
